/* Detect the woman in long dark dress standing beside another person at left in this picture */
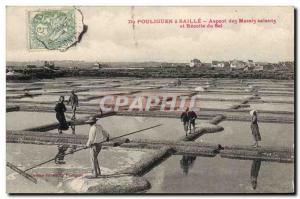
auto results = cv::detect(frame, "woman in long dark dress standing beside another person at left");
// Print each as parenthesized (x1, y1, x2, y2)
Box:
(55, 96, 69, 134)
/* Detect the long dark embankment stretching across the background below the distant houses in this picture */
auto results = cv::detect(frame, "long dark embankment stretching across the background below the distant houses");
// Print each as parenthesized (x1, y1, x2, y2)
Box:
(6, 66, 294, 81)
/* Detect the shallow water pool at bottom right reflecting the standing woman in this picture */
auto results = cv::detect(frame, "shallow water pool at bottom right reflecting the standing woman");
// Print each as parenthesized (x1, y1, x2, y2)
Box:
(145, 155, 294, 193)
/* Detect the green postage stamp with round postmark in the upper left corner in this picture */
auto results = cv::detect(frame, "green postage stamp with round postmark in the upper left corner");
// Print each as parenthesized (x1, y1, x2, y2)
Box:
(28, 8, 83, 51)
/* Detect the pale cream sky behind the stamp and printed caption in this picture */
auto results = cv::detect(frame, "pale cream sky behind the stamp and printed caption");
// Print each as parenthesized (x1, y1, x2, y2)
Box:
(6, 7, 294, 62)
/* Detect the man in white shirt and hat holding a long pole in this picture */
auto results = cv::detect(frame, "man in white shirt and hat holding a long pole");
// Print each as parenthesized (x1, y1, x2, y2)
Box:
(86, 117, 109, 178)
